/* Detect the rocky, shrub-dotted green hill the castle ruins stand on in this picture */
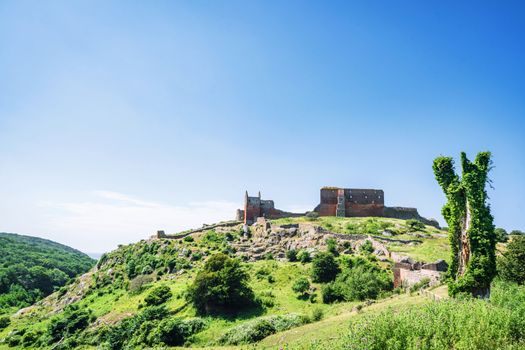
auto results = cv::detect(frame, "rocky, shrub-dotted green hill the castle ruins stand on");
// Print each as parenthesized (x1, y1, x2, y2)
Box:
(0, 217, 448, 348)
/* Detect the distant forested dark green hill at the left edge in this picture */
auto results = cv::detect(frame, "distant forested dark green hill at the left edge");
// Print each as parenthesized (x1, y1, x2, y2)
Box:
(0, 233, 95, 314)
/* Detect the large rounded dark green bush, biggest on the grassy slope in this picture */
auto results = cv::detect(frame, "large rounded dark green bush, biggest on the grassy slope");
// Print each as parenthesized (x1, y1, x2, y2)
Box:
(187, 253, 254, 314)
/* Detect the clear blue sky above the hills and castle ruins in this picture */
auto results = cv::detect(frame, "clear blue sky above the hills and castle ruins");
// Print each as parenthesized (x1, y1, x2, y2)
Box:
(0, 0, 525, 252)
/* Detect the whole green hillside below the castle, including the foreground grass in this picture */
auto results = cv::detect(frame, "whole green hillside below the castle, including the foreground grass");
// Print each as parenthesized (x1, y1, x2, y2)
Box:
(0, 218, 525, 349)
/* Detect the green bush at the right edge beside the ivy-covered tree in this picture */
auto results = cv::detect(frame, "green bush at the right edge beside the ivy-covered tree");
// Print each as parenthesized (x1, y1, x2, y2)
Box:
(498, 236, 525, 284)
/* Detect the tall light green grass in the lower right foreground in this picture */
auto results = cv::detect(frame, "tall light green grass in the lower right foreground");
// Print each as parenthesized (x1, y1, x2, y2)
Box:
(324, 285, 525, 350)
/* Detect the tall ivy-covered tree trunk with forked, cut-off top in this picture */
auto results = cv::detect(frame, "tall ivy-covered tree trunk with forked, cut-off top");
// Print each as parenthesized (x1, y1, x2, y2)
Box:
(433, 152, 496, 298)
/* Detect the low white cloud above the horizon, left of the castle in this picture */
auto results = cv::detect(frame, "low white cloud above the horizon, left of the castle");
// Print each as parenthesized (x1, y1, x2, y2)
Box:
(37, 191, 239, 252)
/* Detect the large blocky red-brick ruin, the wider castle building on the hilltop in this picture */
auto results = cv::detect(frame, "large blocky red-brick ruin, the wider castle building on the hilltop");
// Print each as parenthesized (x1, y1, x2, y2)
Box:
(315, 187, 385, 217)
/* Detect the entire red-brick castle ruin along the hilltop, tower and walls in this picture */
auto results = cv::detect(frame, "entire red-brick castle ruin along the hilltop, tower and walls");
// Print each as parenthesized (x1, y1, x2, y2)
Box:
(236, 187, 439, 227)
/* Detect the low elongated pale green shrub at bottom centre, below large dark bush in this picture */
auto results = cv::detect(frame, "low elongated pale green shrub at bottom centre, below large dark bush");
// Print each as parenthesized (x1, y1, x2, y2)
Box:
(218, 314, 310, 345)
